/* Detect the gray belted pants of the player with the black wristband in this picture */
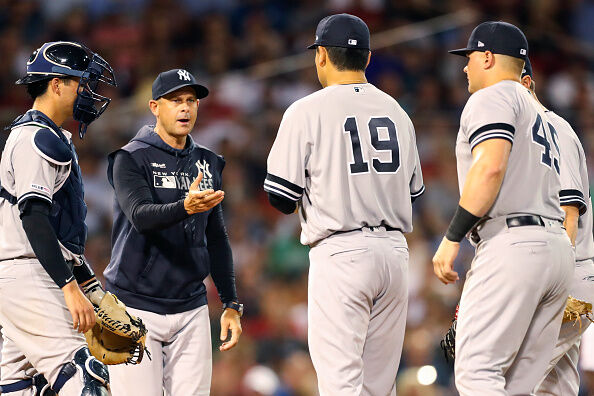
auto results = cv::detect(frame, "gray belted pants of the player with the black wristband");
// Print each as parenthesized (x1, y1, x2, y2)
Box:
(454, 217, 575, 396)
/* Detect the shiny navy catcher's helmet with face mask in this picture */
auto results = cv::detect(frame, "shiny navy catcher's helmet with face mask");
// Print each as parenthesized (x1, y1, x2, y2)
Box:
(16, 41, 117, 139)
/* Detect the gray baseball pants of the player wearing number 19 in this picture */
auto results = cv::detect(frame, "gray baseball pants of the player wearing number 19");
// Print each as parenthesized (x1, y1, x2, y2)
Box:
(308, 227, 408, 396)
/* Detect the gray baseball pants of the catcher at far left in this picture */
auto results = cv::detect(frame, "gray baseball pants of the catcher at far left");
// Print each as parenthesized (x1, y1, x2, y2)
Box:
(0, 259, 87, 396)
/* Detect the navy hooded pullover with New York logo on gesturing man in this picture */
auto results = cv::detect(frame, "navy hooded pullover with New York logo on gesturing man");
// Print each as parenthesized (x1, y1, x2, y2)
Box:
(104, 126, 237, 314)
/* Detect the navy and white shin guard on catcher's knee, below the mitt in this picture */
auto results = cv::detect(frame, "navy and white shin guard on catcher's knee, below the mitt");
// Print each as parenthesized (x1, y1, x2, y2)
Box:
(52, 347, 110, 396)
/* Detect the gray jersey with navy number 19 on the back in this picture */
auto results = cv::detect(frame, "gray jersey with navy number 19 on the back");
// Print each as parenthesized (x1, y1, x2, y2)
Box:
(264, 83, 424, 244)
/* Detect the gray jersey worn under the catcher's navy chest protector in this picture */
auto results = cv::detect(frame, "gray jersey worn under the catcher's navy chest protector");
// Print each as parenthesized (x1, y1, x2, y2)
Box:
(0, 123, 74, 261)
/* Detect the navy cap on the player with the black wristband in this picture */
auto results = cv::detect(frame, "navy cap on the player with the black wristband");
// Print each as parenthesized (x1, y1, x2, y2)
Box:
(449, 22, 528, 60)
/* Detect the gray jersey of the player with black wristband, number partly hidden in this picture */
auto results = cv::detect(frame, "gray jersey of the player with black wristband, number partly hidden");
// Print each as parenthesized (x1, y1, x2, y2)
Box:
(456, 80, 565, 220)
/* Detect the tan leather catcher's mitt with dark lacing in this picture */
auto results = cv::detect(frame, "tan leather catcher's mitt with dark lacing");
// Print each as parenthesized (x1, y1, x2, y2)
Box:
(85, 292, 150, 364)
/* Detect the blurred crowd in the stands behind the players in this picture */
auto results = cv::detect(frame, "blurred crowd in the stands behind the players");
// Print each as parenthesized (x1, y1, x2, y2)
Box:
(0, 0, 594, 396)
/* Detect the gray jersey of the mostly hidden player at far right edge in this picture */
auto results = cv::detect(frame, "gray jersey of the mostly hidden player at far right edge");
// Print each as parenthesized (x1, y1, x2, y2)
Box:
(546, 111, 594, 261)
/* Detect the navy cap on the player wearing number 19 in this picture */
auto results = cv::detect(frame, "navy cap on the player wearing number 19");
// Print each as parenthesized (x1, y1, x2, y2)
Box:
(307, 14, 370, 49)
